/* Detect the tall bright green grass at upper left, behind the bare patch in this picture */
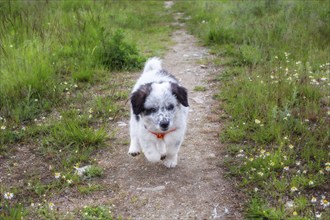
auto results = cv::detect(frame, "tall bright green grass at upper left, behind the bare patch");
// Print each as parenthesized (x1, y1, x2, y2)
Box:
(0, 0, 169, 122)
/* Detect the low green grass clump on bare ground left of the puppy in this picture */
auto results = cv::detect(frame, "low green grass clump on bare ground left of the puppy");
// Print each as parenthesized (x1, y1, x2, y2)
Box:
(40, 111, 106, 168)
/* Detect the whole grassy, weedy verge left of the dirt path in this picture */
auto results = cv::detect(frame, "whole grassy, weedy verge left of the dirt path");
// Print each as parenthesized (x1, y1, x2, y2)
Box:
(0, 0, 172, 219)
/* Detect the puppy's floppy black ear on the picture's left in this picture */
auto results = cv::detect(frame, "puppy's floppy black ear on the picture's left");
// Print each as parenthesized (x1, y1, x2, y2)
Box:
(131, 83, 151, 115)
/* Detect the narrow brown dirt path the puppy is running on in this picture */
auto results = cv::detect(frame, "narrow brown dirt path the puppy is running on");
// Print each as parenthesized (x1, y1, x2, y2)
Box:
(57, 4, 242, 219)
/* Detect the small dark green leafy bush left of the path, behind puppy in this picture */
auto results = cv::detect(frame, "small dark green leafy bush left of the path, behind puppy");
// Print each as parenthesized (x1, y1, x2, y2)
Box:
(99, 29, 145, 70)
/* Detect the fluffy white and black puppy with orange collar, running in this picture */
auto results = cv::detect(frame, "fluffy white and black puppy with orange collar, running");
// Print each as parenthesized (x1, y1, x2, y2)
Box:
(128, 57, 189, 168)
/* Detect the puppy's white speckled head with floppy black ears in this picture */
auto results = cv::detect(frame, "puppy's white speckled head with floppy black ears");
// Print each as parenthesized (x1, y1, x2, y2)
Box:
(131, 82, 189, 132)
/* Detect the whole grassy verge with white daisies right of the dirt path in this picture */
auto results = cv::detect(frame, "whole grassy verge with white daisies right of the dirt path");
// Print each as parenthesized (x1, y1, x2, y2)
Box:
(176, 0, 330, 219)
